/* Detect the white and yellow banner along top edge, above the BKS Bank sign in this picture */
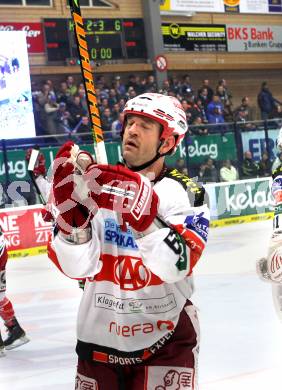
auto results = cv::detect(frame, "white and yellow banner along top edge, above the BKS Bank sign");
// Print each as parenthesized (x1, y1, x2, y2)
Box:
(160, 0, 282, 14)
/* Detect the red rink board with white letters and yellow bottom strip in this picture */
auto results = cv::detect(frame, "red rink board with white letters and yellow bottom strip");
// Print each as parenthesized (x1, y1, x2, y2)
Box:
(0, 205, 52, 257)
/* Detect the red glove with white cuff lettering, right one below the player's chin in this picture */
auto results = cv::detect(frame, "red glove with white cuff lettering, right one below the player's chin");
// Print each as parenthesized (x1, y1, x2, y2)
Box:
(86, 165, 159, 232)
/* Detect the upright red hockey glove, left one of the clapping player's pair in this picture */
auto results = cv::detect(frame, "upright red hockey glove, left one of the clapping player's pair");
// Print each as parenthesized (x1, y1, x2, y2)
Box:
(53, 142, 93, 234)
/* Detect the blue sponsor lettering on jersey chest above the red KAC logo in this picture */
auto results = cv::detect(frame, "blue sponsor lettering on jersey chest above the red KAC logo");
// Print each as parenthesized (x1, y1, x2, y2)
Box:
(105, 218, 138, 250)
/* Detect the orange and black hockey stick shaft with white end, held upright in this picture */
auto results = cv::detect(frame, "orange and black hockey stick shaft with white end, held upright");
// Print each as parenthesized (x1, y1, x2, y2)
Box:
(69, 0, 108, 164)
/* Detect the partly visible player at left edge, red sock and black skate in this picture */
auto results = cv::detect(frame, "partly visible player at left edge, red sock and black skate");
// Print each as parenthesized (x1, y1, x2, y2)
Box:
(0, 230, 29, 356)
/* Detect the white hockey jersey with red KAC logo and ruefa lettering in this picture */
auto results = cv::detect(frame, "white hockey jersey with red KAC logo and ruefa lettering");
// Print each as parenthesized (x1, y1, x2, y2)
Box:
(48, 169, 209, 352)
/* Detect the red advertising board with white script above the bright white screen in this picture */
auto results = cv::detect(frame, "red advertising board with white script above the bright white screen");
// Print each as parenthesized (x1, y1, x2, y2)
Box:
(0, 22, 45, 54)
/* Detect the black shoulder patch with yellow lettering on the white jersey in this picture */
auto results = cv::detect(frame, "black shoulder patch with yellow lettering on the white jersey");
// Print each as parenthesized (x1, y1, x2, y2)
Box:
(165, 168, 206, 207)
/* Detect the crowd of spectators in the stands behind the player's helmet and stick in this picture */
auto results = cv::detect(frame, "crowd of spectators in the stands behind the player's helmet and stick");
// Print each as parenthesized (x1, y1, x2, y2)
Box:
(28, 74, 282, 186)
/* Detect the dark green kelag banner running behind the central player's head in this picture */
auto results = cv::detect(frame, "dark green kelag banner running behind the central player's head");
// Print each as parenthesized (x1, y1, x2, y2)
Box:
(0, 133, 237, 183)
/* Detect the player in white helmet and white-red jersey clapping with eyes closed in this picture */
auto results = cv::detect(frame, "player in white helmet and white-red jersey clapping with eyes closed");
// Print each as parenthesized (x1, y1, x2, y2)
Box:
(49, 93, 209, 390)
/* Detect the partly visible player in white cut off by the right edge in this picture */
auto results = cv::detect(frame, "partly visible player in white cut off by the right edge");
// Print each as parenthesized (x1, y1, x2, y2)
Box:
(257, 128, 282, 320)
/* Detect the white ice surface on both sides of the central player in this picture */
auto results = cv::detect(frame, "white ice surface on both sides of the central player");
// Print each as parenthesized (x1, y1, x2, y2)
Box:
(0, 221, 282, 390)
